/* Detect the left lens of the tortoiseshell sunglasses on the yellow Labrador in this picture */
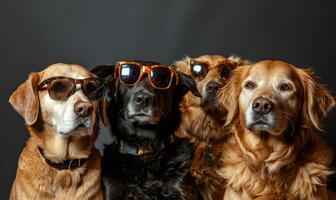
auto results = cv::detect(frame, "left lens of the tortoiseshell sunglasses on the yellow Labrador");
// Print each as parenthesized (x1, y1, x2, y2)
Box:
(49, 78, 74, 101)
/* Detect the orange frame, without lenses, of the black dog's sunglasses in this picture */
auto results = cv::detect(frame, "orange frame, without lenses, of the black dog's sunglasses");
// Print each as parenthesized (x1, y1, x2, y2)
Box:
(114, 61, 179, 90)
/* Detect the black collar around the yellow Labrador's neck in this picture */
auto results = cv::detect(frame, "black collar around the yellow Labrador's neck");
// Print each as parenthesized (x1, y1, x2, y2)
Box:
(37, 147, 89, 170)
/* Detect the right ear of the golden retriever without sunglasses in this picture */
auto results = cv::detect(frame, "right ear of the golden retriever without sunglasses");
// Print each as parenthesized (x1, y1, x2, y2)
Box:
(298, 69, 336, 131)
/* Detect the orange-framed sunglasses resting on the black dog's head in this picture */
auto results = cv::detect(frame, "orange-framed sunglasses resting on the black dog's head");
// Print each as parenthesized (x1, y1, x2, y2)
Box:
(114, 61, 178, 89)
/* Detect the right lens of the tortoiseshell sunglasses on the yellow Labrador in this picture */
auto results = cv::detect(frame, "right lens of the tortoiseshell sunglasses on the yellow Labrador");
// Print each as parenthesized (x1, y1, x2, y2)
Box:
(83, 79, 105, 100)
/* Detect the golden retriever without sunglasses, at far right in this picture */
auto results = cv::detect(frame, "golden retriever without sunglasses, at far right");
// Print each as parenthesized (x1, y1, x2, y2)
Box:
(218, 60, 335, 200)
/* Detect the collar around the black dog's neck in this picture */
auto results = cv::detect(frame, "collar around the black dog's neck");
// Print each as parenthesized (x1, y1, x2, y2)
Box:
(116, 137, 174, 156)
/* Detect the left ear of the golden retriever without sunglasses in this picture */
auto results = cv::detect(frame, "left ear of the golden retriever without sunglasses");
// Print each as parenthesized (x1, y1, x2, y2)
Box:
(219, 66, 247, 126)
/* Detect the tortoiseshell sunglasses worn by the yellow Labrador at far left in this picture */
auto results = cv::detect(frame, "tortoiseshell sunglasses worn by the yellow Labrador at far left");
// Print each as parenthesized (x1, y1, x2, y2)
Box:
(37, 76, 106, 101)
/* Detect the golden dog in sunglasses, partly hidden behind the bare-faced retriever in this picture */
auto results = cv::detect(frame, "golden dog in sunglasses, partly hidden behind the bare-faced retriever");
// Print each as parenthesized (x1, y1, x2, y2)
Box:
(176, 55, 250, 200)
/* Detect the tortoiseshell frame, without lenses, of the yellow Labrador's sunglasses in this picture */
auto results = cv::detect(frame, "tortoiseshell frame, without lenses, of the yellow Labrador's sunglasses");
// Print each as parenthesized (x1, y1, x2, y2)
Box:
(37, 76, 107, 101)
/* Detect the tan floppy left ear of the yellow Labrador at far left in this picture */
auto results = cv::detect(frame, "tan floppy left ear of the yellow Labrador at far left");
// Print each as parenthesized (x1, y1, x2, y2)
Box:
(9, 72, 40, 125)
